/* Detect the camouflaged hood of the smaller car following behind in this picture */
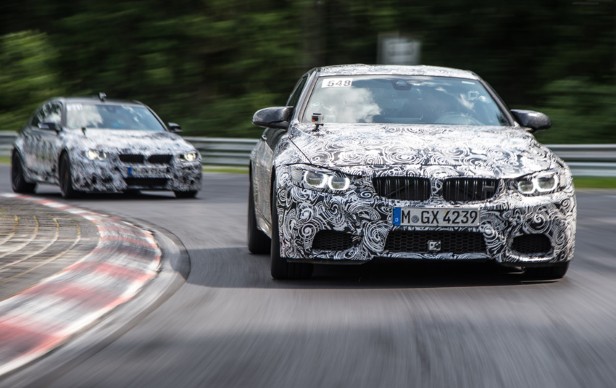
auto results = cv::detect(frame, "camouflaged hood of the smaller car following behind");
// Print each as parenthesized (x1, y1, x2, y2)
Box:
(74, 129, 194, 153)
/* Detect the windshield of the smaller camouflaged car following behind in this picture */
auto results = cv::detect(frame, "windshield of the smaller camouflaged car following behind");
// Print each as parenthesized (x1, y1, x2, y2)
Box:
(66, 103, 165, 131)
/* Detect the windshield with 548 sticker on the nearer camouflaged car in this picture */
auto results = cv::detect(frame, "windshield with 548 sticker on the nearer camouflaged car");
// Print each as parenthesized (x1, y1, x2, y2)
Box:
(302, 76, 509, 126)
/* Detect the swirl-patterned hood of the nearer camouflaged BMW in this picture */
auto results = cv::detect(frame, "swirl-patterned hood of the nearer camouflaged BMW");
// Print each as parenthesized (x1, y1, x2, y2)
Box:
(290, 124, 562, 178)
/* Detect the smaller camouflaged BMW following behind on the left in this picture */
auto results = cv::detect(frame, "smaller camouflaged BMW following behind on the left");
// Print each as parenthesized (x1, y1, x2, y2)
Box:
(11, 93, 201, 198)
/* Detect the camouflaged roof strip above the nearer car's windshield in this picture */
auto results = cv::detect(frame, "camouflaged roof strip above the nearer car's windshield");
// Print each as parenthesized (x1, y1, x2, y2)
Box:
(315, 64, 479, 79)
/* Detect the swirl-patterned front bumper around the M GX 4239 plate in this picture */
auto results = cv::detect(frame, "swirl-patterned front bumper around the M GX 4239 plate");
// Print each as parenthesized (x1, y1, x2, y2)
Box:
(276, 165, 576, 265)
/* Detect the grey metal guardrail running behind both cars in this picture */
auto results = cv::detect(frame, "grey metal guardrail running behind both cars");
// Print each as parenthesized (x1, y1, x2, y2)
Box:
(0, 132, 616, 177)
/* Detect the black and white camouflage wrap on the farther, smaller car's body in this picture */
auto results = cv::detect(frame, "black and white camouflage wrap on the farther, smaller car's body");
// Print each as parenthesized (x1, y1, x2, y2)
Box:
(15, 129, 201, 193)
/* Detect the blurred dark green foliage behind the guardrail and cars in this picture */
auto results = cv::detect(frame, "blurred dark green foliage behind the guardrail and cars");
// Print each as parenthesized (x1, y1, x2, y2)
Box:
(0, 0, 616, 143)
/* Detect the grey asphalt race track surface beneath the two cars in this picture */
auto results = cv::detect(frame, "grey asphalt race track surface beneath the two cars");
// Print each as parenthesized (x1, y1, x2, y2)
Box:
(0, 166, 616, 388)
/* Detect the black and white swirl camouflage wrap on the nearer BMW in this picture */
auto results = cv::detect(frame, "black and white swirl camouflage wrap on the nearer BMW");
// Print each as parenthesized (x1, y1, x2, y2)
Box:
(251, 65, 576, 266)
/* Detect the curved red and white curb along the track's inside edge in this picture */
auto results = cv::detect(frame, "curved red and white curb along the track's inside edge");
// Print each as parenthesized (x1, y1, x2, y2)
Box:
(0, 194, 162, 376)
